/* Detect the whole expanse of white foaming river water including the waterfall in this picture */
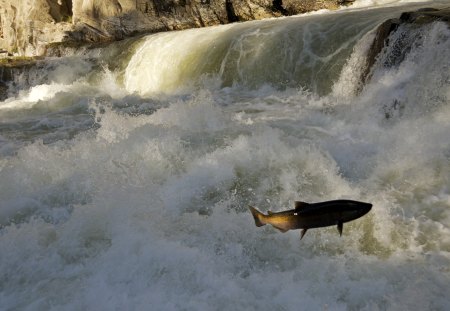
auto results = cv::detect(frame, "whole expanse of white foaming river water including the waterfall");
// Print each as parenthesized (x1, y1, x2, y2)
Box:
(0, 1, 450, 310)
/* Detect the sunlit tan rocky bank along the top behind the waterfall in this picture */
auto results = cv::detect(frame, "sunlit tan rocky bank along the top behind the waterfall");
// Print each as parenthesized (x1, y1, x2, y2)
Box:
(0, 0, 344, 56)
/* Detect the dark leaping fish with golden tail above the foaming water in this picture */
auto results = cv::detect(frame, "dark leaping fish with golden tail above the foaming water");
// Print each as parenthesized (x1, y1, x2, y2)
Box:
(249, 200, 372, 239)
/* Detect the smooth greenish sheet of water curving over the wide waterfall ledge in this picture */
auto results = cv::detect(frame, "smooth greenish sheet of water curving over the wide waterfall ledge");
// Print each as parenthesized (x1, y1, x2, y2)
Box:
(124, 11, 387, 95)
